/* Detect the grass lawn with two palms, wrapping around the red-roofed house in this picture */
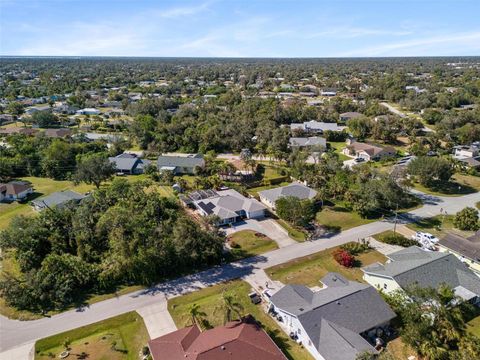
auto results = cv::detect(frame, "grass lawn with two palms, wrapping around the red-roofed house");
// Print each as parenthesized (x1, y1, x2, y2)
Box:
(168, 280, 312, 360)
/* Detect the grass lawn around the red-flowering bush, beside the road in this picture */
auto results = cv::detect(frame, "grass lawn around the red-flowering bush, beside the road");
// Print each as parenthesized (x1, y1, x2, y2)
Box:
(265, 247, 386, 287)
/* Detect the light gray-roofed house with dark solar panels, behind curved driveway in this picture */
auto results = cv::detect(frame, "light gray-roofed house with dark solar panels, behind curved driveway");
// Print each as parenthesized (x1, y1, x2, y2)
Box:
(188, 189, 266, 225)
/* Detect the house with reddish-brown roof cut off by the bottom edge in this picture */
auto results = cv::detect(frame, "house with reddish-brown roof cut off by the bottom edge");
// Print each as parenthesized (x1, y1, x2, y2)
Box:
(148, 316, 287, 360)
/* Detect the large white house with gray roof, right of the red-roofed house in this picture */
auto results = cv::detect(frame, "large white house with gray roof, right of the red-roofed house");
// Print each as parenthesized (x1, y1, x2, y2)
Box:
(270, 273, 395, 360)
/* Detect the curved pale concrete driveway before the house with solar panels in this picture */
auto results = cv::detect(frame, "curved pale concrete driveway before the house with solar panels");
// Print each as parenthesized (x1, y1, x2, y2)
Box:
(225, 218, 297, 248)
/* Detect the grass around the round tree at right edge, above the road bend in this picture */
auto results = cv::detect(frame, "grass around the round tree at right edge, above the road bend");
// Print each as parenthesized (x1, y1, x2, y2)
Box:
(413, 174, 480, 196)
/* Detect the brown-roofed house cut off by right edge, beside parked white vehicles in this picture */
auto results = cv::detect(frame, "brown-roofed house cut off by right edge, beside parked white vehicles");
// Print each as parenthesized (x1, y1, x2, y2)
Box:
(437, 232, 480, 276)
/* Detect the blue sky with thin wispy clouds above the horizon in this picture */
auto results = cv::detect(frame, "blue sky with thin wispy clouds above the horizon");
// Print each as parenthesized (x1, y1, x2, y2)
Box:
(0, 0, 480, 57)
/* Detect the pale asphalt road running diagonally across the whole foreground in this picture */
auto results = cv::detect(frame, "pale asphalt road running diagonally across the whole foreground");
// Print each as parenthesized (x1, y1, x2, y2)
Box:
(0, 193, 480, 359)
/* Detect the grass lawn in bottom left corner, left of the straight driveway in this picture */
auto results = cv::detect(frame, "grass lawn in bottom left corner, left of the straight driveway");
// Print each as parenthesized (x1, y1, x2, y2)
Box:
(35, 311, 150, 360)
